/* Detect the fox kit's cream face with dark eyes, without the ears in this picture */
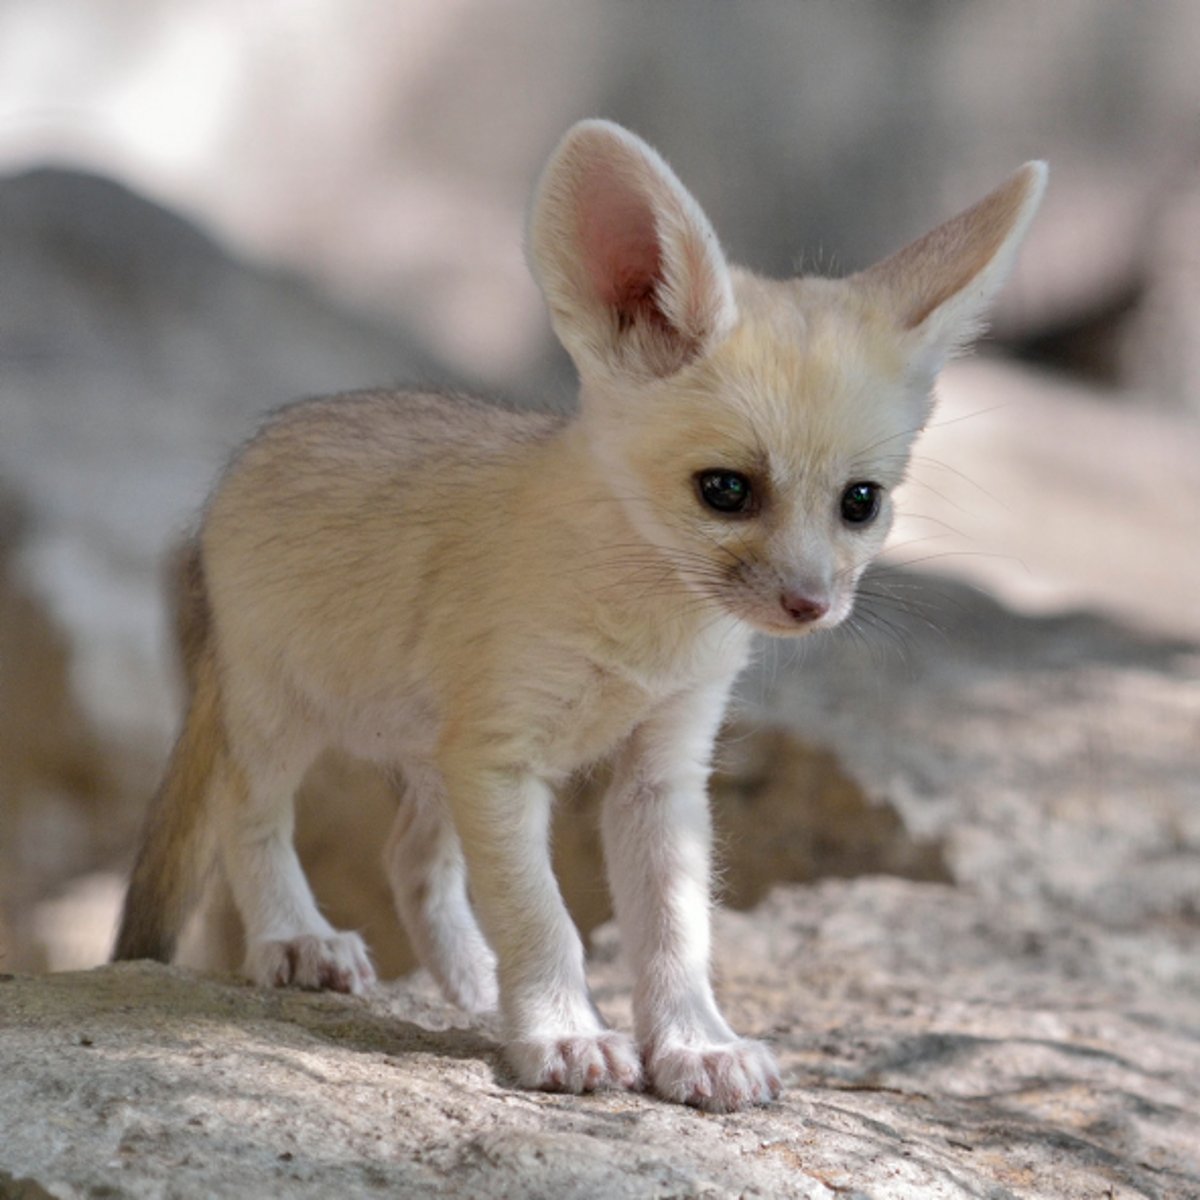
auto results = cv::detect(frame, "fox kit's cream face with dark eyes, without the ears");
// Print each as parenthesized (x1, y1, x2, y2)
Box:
(588, 281, 924, 636)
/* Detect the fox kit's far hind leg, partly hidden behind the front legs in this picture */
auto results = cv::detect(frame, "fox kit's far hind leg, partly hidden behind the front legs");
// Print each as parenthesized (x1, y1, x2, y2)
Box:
(384, 766, 497, 1013)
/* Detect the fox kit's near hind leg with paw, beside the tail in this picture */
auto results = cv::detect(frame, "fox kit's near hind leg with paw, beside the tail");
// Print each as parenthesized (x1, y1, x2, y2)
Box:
(215, 726, 376, 992)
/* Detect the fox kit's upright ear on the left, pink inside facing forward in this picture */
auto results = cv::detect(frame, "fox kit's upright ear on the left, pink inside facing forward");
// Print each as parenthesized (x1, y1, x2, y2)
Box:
(529, 121, 737, 378)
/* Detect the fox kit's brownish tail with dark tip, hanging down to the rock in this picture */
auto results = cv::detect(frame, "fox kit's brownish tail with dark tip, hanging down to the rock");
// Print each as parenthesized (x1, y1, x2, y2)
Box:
(113, 541, 224, 962)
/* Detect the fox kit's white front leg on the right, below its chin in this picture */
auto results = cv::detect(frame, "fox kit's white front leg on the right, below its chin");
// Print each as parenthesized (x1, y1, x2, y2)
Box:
(604, 688, 780, 1112)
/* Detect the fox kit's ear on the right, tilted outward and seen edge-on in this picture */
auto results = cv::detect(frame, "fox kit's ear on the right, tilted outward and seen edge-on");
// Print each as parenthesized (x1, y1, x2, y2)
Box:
(853, 162, 1046, 380)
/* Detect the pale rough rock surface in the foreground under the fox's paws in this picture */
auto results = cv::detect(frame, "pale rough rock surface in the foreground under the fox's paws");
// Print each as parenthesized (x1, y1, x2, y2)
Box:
(0, 878, 1200, 1200)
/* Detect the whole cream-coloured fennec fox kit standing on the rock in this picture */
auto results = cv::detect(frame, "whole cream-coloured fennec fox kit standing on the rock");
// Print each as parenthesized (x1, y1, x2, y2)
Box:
(116, 121, 1045, 1111)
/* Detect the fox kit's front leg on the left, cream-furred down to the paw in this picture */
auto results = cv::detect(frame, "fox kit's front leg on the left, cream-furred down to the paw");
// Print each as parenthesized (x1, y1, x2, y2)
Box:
(444, 755, 642, 1092)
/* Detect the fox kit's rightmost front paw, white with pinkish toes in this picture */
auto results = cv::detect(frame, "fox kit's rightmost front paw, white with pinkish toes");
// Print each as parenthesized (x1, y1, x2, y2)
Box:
(647, 1038, 781, 1112)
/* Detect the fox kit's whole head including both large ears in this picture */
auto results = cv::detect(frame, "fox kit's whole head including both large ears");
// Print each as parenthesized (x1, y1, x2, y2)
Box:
(530, 121, 1046, 635)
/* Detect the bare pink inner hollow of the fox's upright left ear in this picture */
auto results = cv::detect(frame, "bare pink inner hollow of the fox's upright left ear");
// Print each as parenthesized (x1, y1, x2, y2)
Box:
(578, 170, 662, 325)
